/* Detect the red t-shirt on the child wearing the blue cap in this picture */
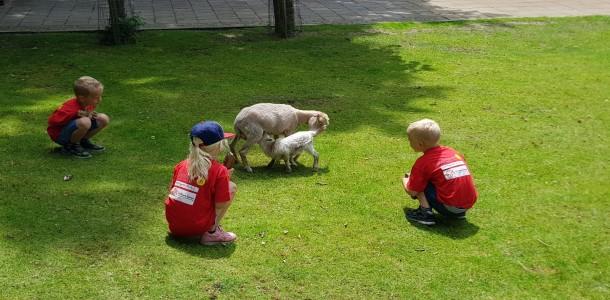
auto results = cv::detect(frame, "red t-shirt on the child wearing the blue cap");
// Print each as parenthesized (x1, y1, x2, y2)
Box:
(165, 160, 231, 236)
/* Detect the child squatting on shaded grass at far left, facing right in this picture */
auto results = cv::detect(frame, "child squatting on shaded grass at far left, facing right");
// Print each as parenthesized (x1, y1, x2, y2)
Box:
(47, 76, 110, 158)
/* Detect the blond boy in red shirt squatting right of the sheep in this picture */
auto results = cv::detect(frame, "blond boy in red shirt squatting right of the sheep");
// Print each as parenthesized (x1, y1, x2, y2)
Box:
(403, 119, 477, 225)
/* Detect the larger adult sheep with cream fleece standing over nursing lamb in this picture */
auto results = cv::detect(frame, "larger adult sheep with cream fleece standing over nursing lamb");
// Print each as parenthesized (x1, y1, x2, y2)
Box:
(230, 103, 329, 173)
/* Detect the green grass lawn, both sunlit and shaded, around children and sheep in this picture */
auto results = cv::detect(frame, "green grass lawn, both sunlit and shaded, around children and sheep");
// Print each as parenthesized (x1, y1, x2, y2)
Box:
(0, 17, 610, 299)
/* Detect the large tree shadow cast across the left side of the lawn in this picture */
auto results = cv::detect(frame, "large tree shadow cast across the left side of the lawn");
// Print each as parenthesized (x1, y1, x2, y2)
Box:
(0, 21, 490, 256)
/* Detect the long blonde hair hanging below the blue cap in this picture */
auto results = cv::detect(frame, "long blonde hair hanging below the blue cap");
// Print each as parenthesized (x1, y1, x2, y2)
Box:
(187, 137, 228, 180)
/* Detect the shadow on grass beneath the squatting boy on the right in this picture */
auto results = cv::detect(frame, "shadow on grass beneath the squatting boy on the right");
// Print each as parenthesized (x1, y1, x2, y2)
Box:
(403, 207, 479, 240)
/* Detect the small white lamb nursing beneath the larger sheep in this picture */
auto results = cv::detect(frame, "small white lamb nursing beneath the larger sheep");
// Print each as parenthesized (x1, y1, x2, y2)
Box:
(260, 130, 320, 172)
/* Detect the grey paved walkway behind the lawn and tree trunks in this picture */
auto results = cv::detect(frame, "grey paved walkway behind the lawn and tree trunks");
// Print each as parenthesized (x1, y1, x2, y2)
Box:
(0, 0, 610, 32)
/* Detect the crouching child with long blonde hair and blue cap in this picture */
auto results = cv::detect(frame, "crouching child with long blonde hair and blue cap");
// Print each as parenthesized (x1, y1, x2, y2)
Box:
(165, 121, 237, 245)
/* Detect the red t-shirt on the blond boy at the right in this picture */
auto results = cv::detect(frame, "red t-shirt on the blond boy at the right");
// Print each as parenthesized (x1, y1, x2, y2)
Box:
(407, 146, 477, 208)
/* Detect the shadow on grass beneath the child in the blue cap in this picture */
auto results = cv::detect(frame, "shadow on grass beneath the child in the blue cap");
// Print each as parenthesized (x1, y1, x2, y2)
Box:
(165, 233, 237, 259)
